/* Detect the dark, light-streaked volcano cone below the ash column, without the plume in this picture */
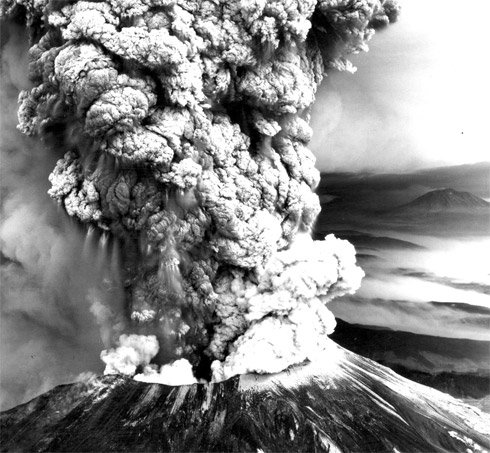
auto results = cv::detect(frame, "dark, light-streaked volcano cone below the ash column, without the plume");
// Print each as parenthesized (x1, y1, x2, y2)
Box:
(0, 342, 490, 452)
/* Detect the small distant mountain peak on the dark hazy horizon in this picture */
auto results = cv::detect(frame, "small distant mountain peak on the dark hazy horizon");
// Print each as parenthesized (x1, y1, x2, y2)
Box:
(396, 188, 490, 212)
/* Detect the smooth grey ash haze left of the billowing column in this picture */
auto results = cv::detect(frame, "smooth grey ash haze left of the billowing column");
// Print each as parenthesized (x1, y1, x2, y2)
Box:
(0, 21, 124, 410)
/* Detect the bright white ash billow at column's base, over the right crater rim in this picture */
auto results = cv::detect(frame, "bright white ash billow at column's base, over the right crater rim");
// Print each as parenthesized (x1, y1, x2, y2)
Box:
(210, 234, 364, 381)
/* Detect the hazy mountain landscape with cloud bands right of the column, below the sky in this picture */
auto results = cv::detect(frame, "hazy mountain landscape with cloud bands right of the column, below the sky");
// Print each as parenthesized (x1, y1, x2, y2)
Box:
(315, 162, 490, 411)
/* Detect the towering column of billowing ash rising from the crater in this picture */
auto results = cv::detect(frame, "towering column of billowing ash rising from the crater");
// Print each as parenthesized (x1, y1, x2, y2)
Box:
(3, 0, 398, 379)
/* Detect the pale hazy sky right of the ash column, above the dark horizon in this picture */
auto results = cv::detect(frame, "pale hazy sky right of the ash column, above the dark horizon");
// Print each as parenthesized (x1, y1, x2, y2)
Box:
(311, 0, 490, 172)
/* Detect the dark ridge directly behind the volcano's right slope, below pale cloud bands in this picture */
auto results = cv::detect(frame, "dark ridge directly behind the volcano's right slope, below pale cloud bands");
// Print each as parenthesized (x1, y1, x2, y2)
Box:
(331, 320, 490, 399)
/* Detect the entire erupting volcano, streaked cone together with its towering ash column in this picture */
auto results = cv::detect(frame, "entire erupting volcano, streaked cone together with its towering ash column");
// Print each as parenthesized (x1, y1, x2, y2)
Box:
(0, 0, 490, 451)
